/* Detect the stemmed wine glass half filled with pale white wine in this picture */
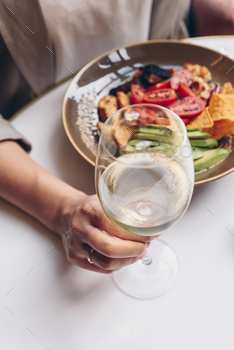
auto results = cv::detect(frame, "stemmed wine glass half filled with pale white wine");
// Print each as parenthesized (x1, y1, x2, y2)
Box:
(95, 104, 194, 299)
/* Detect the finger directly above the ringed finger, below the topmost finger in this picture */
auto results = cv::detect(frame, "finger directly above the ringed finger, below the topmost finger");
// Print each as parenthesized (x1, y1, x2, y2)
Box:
(82, 225, 149, 258)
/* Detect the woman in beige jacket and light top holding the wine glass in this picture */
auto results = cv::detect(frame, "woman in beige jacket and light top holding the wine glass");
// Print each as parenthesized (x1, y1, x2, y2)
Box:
(0, 0, 189, 273)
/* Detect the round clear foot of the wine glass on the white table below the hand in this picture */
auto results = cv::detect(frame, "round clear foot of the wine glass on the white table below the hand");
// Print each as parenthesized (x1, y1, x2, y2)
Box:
(113, 239, 179, 299)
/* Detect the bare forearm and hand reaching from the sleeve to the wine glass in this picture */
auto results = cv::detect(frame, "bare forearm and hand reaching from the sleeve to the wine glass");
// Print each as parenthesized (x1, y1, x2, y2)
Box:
(0, 141, 154, 273)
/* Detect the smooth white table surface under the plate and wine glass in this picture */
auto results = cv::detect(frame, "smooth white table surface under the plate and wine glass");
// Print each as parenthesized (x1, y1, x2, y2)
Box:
(0, 37, 234, 350)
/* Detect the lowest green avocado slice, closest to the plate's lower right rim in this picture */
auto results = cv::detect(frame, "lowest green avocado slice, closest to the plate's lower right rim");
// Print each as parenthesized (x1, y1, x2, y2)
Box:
(194, 148, 229, 171)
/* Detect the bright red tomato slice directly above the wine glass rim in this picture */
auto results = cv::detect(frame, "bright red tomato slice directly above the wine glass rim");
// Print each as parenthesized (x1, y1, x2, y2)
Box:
(143, 89, 177, 106)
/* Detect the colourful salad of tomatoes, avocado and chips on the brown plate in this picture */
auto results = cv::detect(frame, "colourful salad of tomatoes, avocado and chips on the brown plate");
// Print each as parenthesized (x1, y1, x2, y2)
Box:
(98, 63, 234, 171)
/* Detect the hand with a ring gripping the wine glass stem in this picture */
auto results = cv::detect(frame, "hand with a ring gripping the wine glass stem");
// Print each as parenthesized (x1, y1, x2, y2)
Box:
(58, 194, 155, 273)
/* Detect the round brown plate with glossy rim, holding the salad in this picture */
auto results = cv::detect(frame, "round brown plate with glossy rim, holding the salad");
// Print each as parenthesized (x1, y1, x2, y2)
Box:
(62, 40, 234, 185)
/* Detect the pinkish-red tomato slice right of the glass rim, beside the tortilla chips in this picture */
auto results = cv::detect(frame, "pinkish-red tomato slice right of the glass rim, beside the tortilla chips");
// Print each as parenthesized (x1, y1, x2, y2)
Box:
(168, 96, 206, 118)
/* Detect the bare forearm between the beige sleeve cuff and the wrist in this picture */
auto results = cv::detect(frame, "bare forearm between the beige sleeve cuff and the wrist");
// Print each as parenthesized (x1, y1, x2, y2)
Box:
(0, 141, 85, 233)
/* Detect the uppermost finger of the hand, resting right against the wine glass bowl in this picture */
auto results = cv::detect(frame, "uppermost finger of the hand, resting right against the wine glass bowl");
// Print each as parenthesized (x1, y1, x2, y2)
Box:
(89, 203, 159, 242)
